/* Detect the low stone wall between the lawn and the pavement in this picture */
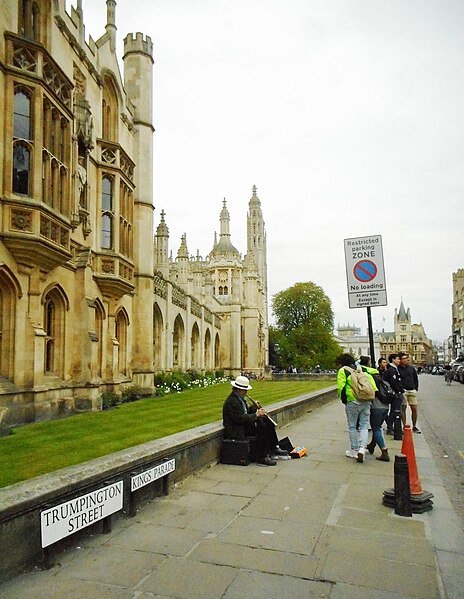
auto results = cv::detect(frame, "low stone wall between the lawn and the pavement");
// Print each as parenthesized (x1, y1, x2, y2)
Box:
(0, 387, 335, 582)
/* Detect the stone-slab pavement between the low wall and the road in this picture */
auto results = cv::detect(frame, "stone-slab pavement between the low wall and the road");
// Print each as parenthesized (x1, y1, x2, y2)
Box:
(0, 400, 464, 599)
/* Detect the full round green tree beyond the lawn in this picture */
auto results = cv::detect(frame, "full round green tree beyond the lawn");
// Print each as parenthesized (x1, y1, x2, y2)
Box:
(271, 282, 341, 370)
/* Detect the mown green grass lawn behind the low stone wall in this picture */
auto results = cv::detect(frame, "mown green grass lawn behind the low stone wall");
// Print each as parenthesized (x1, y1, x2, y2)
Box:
(0, 381, 334, 487)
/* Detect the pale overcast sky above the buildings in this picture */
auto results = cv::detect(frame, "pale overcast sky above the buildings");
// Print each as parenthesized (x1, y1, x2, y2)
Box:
(77, 0, 464, 341)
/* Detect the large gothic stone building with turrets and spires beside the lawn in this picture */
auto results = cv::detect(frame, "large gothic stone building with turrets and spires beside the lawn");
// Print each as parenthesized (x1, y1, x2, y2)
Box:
(0, 0, 268, 424)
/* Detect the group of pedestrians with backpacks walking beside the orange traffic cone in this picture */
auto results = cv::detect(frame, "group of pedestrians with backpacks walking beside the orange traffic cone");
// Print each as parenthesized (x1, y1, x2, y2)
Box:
(337, 352, 421, 463)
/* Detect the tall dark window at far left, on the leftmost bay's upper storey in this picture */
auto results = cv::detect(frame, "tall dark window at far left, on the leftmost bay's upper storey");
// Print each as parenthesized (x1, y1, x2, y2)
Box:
(13, 86, 33, 195)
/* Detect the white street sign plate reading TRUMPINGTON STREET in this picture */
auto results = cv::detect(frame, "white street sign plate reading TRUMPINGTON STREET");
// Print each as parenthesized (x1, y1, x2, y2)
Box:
(40, 480, 123, 547)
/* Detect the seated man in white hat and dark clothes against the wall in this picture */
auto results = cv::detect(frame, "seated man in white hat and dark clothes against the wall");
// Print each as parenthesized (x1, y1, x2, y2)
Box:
(222, 376, 288, 466)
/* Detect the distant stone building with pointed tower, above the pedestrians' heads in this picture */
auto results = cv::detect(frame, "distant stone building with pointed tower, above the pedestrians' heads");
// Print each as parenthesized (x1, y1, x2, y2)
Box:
(379, 301, 435, 366)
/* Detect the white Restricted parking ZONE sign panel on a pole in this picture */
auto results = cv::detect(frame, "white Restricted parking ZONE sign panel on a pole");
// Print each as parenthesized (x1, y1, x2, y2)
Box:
(344, 235, 387, 308)
